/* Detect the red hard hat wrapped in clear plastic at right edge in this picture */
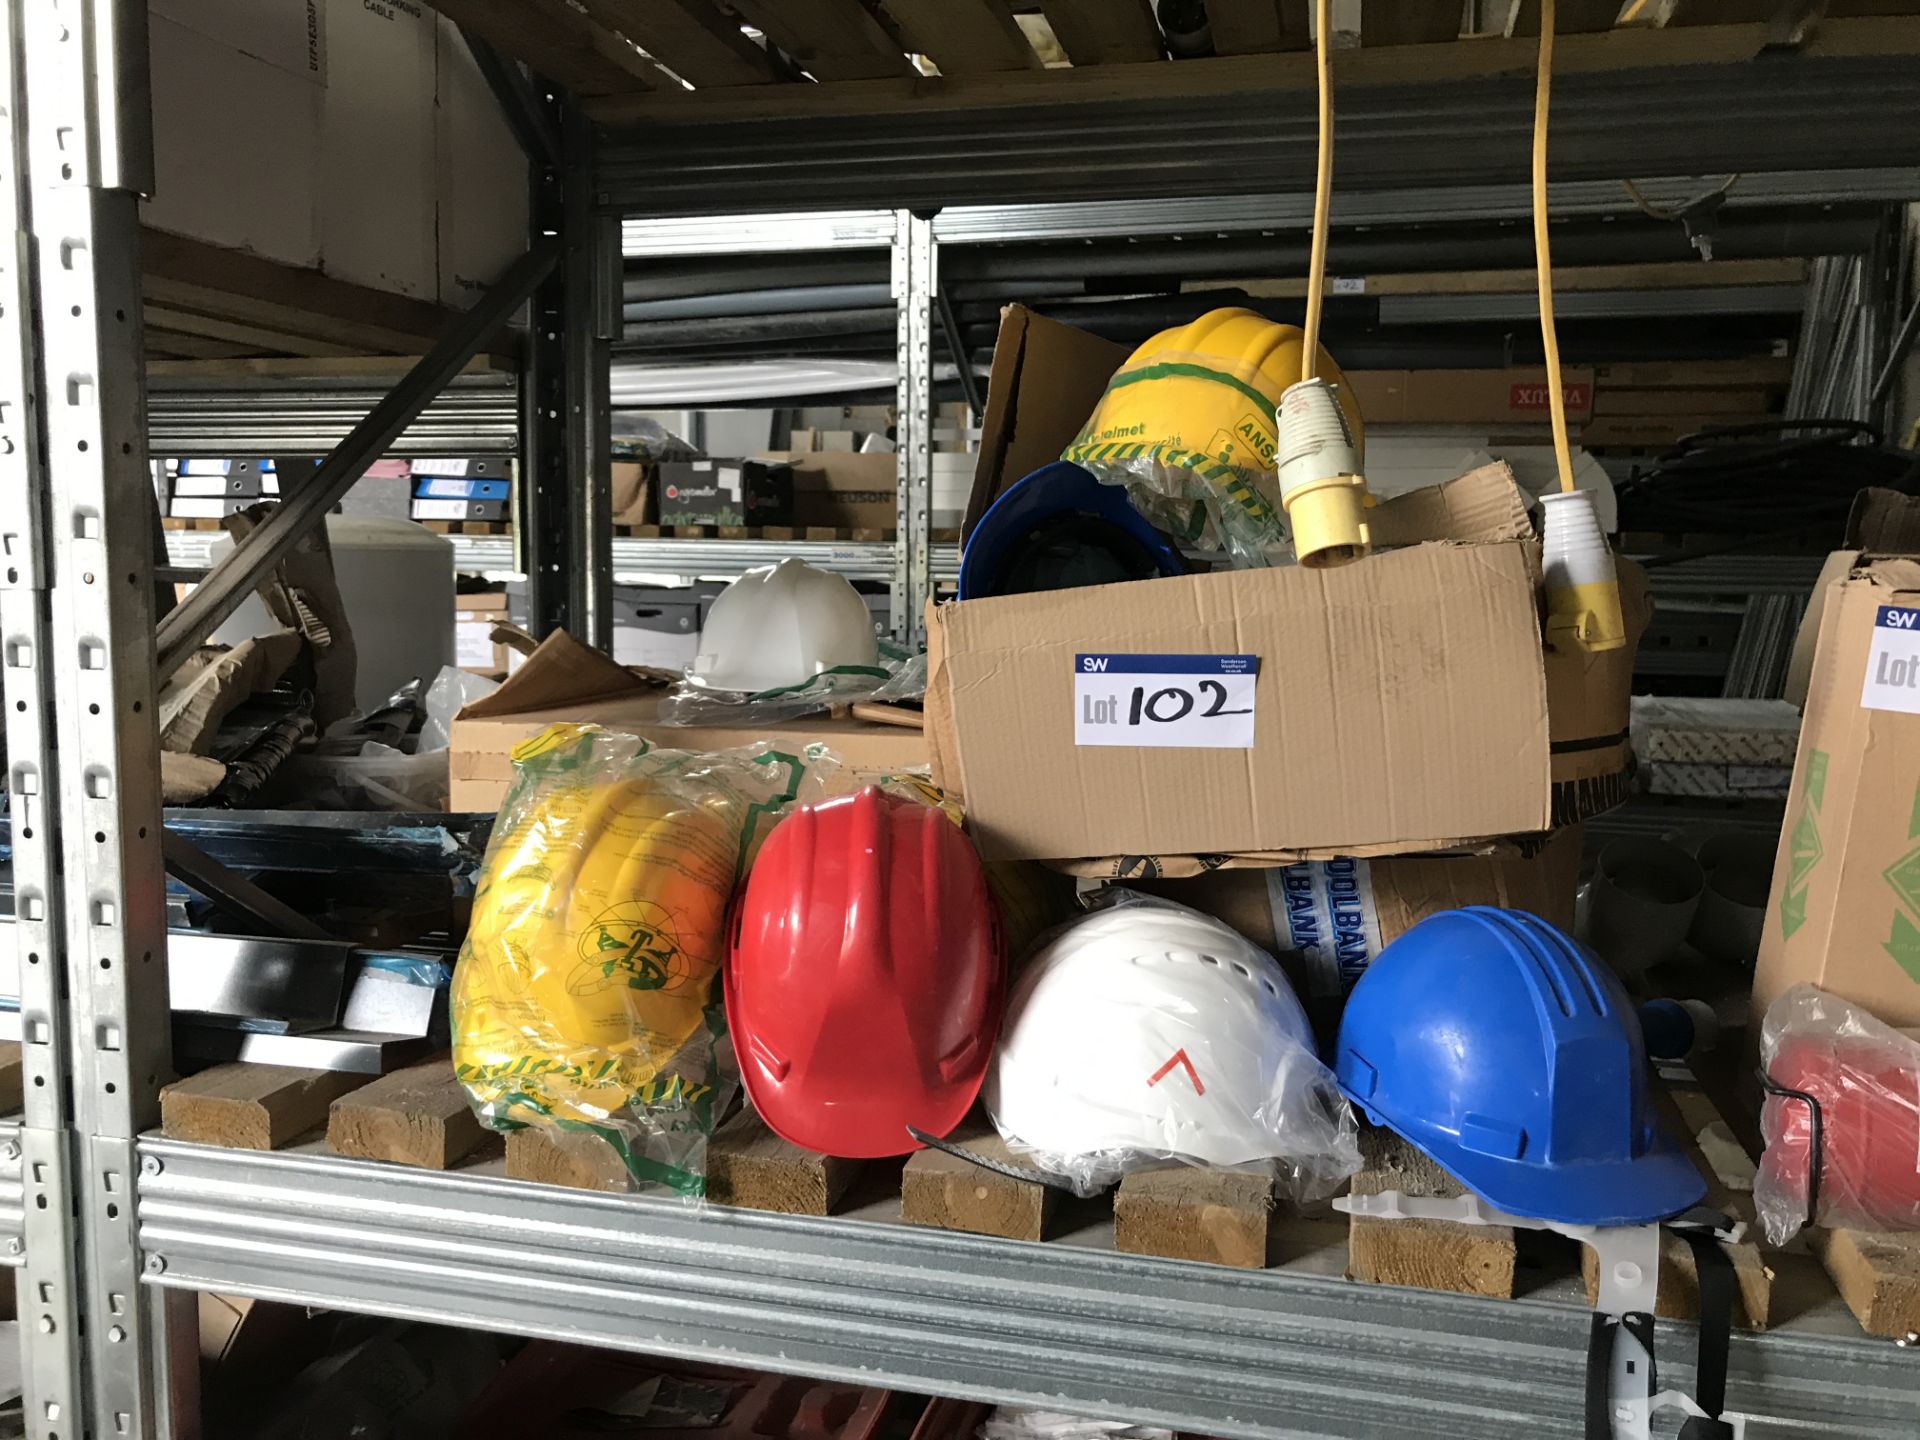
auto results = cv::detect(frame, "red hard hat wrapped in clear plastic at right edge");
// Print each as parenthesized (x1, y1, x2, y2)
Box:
(1761, 1035, 1920, 1231)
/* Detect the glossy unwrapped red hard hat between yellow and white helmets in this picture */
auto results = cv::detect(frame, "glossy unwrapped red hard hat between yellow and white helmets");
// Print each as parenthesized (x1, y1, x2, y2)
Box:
(726, 785, 1006, 1160)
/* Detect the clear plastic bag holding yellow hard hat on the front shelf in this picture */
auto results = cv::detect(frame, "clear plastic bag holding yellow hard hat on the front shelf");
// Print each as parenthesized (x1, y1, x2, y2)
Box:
(451, 724, 835, 1198)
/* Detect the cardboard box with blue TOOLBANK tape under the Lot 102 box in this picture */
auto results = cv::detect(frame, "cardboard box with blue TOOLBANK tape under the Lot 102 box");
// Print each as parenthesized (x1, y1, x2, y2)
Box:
(1129, 826, 1580, 1000)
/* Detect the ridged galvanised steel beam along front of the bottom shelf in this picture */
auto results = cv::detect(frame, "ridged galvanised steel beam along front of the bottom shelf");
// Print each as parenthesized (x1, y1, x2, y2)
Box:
(138, 1137, 1920, 1440)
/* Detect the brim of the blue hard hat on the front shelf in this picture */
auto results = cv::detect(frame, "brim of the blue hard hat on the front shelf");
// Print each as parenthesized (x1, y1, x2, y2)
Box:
(1350, 1096, 1707, 1225)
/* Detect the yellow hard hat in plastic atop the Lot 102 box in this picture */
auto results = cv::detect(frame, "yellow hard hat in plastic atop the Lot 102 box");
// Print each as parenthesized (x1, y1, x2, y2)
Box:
(1062, 309, 1365, 566)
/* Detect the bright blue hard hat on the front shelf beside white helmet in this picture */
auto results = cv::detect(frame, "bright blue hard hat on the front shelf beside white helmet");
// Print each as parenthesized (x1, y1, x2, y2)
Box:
(1334, 906, 1707, 1225)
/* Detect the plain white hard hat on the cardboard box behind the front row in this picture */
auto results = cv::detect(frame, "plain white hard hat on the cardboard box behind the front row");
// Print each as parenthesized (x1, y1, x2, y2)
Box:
(687, 559, 879, 693)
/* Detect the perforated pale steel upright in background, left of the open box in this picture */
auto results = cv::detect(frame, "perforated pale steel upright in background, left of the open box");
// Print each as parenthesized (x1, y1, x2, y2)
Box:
(889, 209, 939, 645)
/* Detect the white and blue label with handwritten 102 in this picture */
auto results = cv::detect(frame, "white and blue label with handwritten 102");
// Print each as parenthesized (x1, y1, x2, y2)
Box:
(1073, 655, 1260, 751)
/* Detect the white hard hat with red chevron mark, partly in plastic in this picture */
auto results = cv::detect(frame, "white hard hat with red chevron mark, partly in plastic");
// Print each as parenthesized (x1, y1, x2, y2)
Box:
(983, 902, 1359, 1190)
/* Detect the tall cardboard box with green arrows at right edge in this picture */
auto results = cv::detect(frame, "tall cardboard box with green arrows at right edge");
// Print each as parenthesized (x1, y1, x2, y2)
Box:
(1753, 557, 1920, 1025)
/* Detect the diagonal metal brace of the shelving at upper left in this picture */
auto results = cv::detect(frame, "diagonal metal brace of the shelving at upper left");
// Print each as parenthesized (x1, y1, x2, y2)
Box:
(153, 238, 561, 684)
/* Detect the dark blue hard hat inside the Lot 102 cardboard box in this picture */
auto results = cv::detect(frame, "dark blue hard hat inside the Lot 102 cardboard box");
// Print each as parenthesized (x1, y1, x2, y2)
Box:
(960, 461, 1187, 599)
